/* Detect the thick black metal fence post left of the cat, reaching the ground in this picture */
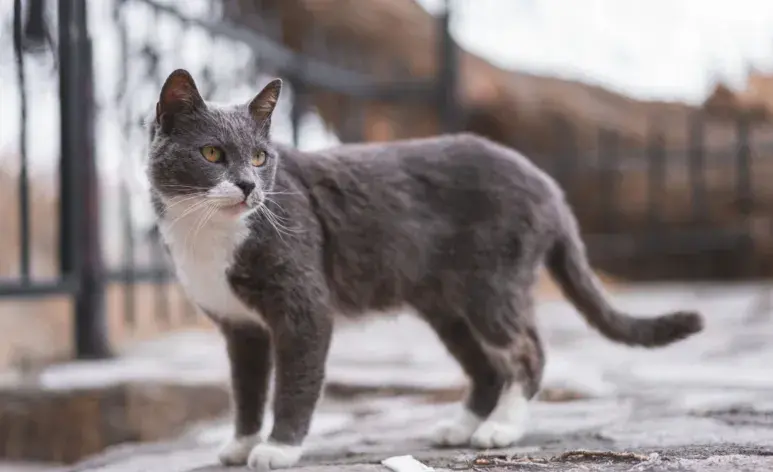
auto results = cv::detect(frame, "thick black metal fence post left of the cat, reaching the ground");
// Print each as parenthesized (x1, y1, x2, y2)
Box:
(58, 0, 110, 359)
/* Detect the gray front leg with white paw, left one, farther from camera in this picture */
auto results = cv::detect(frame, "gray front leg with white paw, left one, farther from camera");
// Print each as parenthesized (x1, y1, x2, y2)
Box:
(218, 323, 271, 465)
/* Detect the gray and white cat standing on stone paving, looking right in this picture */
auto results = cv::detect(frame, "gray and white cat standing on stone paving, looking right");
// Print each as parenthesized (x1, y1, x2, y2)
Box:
(148, 70, 703, 470)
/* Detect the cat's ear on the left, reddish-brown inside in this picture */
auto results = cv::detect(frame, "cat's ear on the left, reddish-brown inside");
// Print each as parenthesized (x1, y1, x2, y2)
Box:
(156, 69, 205, 133)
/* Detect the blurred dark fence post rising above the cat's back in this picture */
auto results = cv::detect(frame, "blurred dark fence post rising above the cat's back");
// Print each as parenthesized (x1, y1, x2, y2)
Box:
(437, 0, 461, 133)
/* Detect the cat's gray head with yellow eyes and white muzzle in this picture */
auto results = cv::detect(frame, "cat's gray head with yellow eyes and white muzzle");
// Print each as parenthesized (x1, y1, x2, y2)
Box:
(147, 69, 282, 216)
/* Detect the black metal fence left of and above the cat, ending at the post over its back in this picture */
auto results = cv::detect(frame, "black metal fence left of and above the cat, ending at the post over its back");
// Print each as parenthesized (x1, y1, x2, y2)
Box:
(0, 0, 456, 358)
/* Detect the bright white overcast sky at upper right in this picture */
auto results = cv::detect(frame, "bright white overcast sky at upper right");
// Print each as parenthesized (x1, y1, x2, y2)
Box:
(420, 0, 773, 102)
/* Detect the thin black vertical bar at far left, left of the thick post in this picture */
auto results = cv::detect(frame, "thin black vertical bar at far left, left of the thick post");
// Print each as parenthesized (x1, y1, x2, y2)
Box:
(13, 0, 30, 283)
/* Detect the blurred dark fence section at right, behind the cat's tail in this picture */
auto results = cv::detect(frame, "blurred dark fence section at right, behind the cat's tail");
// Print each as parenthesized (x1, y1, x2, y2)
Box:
(535, 112, 773, 280)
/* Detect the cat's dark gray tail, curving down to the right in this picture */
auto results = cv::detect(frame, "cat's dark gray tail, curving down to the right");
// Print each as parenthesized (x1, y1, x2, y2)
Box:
(546, 215, 703, 347)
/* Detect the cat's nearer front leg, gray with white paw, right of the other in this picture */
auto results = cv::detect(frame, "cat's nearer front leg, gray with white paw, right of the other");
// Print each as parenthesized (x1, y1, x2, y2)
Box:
(247, 310, 332, 471)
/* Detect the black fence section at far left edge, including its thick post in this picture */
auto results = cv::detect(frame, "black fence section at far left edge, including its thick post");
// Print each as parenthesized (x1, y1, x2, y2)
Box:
(5, 0, 108, 357)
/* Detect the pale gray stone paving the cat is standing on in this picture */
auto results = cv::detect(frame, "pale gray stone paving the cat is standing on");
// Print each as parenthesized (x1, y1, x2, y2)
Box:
(7, 285, 773, 472)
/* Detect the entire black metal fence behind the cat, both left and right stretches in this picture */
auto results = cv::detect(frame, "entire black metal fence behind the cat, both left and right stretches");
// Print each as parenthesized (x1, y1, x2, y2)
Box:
(0, 0, 773, 358)
